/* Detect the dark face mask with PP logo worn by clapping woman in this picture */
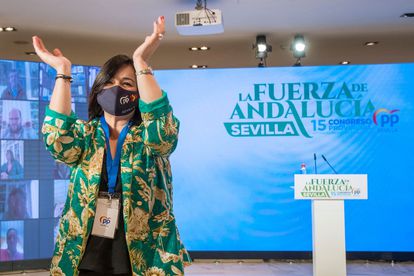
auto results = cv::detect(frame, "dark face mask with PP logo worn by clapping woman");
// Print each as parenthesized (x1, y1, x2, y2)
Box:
(97, 85, 138, 116)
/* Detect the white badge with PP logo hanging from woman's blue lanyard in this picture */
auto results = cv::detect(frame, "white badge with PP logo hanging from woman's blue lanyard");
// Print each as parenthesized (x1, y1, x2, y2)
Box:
(92, 197, 119, 239)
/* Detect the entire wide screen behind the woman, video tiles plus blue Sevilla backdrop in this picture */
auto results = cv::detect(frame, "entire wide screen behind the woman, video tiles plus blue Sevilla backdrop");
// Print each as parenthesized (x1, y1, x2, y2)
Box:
(0, 60, 414, 261)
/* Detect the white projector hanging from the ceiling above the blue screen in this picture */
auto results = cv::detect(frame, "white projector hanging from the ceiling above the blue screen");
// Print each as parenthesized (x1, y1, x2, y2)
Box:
(175, 8, 224, 35)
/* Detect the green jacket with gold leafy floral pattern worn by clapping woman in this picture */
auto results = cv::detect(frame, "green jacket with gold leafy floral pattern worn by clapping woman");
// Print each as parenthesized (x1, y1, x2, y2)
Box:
(42, 93, 191, 276)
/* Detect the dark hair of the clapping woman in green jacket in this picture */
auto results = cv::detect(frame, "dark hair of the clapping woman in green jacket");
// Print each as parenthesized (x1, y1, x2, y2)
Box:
(88, 55, 142, 125)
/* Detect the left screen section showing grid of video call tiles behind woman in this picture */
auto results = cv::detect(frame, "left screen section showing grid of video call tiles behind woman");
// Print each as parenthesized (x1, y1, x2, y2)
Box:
(0, 60, 99, 261)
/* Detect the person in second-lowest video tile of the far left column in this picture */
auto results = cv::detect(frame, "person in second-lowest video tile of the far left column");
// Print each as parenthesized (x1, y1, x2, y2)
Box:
(4, 188, 29, 220)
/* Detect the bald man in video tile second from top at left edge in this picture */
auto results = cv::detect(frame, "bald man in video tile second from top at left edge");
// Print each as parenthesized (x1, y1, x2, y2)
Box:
(2, 108, 37, 139)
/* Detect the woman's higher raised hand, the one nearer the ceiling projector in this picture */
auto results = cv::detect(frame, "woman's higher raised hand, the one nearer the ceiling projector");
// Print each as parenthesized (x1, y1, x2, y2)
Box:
(133, 16, 165, 62)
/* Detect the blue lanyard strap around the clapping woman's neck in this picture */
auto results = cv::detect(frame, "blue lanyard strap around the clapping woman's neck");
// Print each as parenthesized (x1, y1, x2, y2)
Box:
(101, 115, 132, 194)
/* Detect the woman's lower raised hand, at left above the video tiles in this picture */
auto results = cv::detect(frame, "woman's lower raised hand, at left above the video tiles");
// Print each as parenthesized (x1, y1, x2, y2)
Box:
(33, 36, 72, 76)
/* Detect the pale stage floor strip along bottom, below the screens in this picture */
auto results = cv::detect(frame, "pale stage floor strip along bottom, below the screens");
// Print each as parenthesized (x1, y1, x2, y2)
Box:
(0, 260, 414, 276)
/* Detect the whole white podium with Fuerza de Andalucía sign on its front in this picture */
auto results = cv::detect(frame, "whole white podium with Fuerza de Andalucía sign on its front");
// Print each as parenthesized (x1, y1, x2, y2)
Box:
(295, 174, 368, 276)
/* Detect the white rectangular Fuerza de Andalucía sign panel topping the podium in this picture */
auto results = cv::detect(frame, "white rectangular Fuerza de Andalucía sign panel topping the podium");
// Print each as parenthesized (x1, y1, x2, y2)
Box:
(295, 174, 368, 199)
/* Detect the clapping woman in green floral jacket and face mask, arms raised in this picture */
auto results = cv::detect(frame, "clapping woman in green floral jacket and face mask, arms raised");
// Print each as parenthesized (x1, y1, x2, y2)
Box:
(33, 17, 191, 276)
